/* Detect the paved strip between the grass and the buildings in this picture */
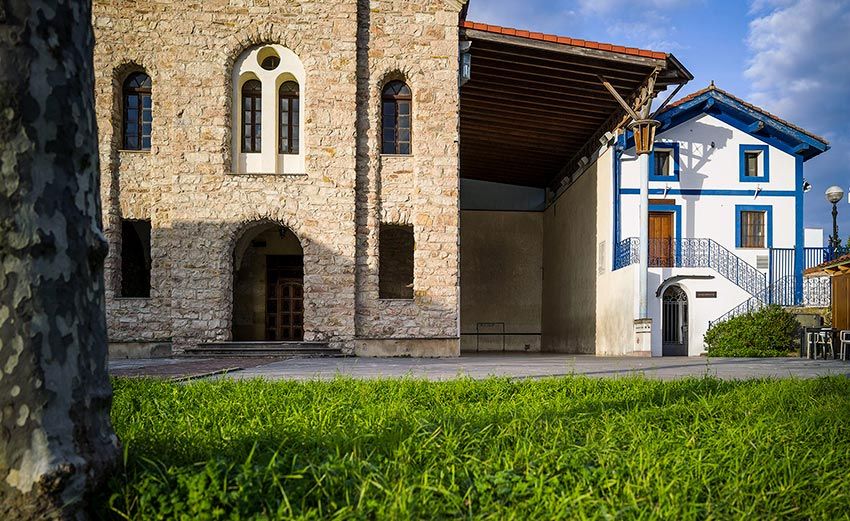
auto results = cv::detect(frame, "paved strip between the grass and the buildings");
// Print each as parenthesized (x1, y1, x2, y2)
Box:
(109, 354, 850, 380)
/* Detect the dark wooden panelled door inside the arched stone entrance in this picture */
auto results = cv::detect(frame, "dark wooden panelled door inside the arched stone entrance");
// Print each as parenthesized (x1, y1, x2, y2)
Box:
(266, 255, 304, 341)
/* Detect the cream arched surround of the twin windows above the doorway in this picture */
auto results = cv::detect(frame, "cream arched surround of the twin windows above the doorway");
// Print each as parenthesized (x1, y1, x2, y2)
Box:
(230, 44, 307, 174)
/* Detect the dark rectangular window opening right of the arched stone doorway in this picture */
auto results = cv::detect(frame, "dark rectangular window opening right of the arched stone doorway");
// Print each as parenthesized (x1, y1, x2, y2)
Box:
(378, 224, 414, 300)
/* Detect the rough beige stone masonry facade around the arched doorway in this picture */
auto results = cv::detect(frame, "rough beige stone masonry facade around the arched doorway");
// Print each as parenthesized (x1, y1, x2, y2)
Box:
(93, 0, 460, 350)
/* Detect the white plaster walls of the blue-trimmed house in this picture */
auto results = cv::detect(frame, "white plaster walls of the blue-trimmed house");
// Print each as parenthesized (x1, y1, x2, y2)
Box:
(600, 114, 800, 356)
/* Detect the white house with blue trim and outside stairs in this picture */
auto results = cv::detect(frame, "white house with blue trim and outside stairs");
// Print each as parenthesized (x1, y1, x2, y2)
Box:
(608, 85, 830, 356)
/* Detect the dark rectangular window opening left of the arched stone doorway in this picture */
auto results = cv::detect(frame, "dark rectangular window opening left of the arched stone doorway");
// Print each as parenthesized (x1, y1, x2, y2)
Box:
(121, 219, 151, 298)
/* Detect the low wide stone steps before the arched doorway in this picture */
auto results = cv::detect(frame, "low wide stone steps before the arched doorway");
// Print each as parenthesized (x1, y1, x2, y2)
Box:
(183, 342, 346, 358)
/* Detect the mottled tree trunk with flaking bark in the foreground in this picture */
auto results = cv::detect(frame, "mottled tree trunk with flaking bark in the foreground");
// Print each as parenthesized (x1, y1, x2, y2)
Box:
(0, 0, 118, 521)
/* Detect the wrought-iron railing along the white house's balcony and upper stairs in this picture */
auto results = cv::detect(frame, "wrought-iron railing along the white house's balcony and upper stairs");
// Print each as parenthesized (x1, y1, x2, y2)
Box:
(614, 237, 767, 296)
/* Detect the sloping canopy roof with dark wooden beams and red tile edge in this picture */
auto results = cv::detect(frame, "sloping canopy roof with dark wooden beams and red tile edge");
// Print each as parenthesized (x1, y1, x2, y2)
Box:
(460, 21, 693, 189)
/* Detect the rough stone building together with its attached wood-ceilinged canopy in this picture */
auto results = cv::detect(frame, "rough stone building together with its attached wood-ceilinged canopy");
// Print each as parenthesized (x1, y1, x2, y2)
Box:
(93, 0, 708, 356)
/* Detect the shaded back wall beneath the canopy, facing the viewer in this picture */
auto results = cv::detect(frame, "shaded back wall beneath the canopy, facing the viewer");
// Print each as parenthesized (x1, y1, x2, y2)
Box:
(460, 211, 543, 351)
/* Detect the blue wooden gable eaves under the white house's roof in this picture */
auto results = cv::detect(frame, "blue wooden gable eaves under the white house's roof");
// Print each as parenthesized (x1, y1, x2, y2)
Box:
(652, 90, 829, 161)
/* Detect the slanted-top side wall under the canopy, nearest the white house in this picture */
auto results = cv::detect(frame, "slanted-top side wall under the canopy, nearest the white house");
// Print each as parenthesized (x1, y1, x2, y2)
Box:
(542, 162, 607, 354)
